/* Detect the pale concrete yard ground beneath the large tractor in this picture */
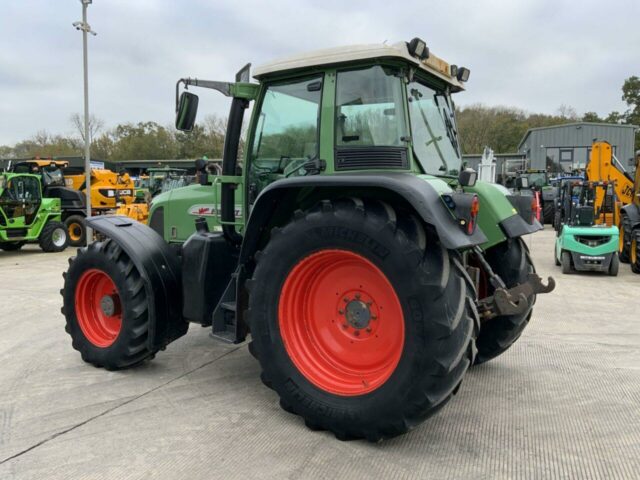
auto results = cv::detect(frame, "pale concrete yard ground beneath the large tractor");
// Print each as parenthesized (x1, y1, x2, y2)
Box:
(0, 231, 640, 480)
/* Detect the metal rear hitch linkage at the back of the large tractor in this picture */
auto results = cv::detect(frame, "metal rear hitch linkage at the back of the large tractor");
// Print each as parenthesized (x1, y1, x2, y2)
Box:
(471, 246, 556, 321)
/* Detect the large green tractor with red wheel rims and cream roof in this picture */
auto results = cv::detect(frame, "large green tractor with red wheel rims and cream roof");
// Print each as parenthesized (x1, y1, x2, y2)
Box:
(62, 38, 555, 441)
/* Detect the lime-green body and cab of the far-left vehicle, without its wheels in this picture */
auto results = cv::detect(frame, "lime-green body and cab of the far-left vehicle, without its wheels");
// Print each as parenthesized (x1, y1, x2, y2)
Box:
(0, 173, 62, 242)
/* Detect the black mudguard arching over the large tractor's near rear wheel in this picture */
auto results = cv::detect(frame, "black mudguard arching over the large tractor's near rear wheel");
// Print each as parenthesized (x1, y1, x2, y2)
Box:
(240, 173, 487, 263)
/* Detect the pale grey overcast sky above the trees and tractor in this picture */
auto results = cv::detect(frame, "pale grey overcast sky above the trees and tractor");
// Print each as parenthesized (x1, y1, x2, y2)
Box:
(0, 0, 640, 145)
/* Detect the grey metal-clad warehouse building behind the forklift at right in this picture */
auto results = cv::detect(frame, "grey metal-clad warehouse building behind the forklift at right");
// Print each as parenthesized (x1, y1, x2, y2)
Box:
(518, 122, 638, 172)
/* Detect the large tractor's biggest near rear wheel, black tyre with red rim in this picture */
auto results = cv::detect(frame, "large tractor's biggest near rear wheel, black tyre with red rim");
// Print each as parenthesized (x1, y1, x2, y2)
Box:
(246, 199, 479, 441)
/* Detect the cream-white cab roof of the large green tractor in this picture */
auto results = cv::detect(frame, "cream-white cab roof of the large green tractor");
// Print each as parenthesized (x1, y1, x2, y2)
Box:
(253, 42, 464, 92)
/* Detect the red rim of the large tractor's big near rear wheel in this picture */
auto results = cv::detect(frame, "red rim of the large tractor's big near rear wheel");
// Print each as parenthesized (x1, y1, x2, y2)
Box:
(278, 249, 405, 396)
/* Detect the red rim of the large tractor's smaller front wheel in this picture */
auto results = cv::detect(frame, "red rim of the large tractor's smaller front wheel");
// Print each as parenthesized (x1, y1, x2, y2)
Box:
(75, 268, 122, 348)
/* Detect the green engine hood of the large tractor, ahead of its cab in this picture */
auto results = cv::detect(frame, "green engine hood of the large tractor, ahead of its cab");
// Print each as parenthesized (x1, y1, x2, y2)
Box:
(149, 175, 244, 243)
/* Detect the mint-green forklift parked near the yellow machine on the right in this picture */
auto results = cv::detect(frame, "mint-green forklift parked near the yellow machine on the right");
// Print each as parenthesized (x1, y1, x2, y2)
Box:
(554, 178, 620, 276)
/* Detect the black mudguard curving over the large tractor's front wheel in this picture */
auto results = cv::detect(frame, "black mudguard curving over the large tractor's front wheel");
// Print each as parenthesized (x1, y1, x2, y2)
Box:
(86, 215, 189, 350)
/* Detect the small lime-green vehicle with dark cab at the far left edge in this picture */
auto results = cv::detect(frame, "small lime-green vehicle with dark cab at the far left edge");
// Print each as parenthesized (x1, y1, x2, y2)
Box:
(0, 173, 69, 252)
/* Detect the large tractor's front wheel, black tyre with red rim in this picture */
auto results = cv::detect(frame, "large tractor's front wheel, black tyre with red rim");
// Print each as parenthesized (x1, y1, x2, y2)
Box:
(61, 239, 155, 370)
